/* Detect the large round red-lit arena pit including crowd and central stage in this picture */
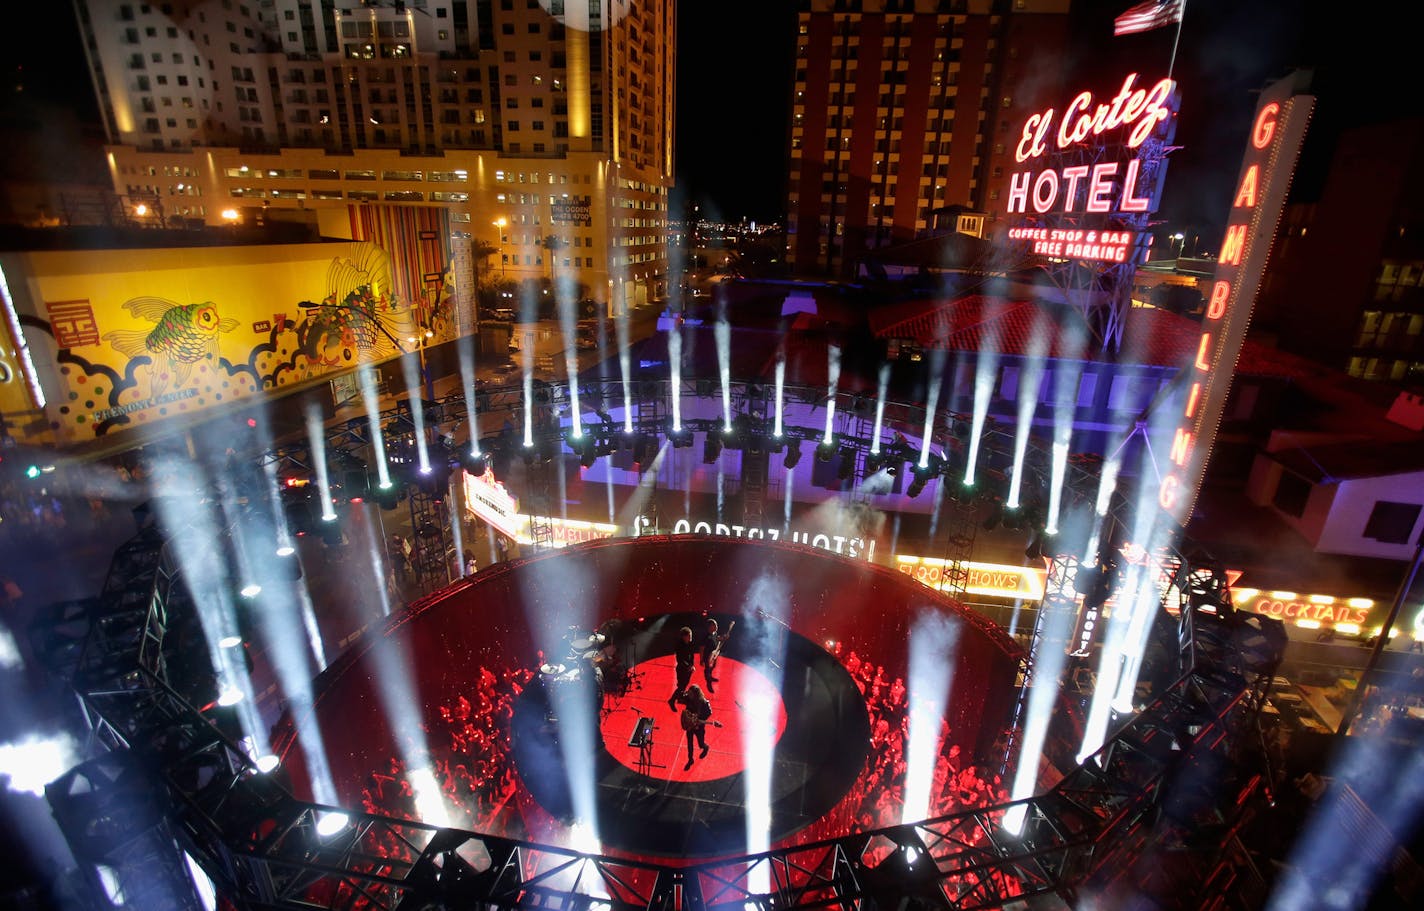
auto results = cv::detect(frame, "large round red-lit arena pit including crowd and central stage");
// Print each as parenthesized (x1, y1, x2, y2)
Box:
(278, 537, 1020, 860)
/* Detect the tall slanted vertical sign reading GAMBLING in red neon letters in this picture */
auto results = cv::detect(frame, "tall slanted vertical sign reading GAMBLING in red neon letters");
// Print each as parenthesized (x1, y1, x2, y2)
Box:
(1158, 74, 1314, 521)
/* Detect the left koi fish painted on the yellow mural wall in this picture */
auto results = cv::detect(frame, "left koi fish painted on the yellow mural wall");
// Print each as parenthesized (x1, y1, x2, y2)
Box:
(104, 297, 238, 396)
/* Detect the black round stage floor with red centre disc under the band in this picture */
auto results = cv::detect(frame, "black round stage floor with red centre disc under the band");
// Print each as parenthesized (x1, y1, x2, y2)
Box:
(513, 614, 870, 855)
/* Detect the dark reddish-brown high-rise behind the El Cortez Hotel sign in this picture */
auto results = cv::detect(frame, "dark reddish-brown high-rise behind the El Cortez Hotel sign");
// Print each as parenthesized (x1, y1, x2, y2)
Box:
(787, 0, 1069, 276)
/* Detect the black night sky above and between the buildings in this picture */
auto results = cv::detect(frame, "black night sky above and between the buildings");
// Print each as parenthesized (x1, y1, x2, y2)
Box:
(0, 0, 1424, 236)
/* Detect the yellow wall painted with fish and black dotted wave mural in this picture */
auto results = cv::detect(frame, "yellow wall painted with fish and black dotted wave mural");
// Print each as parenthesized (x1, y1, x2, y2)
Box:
(0, 242, 453, 443)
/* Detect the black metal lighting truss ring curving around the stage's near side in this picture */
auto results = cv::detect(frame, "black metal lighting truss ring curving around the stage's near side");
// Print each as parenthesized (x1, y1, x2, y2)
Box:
(36, 375, 1284, 911)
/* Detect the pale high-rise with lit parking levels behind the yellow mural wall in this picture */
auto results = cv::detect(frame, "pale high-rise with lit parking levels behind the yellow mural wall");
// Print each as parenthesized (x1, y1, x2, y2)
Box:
(75, 0, 675, 310)
